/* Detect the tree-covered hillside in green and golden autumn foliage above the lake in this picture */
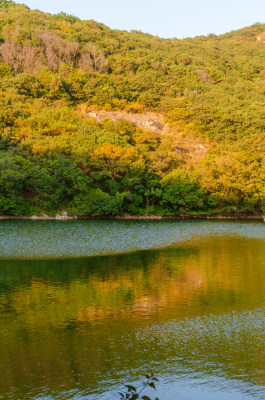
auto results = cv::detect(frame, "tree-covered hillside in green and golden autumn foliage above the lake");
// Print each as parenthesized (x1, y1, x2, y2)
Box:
(0, 0, 265, 216)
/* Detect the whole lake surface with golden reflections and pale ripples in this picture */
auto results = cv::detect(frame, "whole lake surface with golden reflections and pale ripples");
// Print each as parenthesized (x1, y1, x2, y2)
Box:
(0, 220, 265, 400)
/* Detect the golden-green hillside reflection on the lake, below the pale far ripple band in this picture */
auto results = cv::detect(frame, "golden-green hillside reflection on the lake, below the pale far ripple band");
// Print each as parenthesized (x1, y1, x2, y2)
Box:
(0, 230, 265, 399)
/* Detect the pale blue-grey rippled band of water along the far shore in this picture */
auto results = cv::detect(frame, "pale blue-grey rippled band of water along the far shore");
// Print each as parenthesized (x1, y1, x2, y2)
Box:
(0, 220, 265, 259)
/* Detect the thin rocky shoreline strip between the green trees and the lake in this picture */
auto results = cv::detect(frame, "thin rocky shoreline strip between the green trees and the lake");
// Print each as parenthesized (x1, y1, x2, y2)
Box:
(0, 214, 265, 222)
